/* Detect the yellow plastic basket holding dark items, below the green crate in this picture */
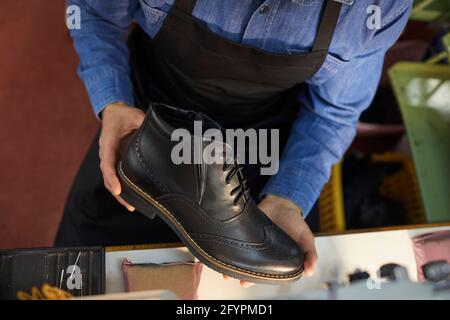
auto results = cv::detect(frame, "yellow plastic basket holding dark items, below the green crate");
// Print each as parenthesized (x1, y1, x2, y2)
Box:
(318, 152, 426, 233)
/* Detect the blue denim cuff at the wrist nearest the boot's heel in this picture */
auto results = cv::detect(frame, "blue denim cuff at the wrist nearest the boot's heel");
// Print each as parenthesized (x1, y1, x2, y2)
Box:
(81, 68, 134, 119)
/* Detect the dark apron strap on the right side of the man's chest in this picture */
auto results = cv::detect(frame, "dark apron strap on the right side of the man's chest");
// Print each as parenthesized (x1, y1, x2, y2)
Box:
(312, 0, 342, 51)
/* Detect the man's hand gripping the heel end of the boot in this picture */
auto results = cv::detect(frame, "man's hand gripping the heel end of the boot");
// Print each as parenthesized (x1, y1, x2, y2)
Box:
(99, 102, 145, 211)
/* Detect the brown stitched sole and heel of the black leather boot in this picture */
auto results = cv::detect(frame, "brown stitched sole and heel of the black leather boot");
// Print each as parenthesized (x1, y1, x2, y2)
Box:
(117, 161, 303, 284)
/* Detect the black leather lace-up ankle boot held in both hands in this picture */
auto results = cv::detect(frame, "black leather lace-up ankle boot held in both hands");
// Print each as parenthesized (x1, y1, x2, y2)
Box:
(117, 104, 303, 283)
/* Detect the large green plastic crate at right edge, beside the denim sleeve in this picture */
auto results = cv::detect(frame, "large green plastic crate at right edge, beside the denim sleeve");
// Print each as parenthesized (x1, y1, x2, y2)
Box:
(389, 62, 450, 223)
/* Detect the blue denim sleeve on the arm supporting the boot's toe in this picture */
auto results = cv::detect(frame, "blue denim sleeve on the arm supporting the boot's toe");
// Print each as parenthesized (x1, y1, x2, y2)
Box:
(262, 1, 410, 216)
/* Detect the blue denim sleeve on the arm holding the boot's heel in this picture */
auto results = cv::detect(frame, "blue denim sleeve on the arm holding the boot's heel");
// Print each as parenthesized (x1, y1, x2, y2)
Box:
(67, 0, 137, 117)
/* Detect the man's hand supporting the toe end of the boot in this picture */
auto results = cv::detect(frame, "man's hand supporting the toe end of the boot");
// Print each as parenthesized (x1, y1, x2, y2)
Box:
(224, 195, 317, 287)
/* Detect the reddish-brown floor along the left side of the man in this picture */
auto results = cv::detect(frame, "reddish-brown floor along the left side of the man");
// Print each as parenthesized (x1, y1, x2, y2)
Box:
(0, 0, 98, 248)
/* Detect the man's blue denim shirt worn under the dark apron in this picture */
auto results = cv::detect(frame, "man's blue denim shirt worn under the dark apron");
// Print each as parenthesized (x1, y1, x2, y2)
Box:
(67, 0, 413, 215)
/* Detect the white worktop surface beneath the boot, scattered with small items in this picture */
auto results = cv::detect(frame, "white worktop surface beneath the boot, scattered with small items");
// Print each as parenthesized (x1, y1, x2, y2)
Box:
(106, 226, 450, 299)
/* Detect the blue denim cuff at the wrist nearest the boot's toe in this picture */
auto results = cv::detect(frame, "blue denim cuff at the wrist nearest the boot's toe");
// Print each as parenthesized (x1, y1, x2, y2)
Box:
(260, 163, 321, 218)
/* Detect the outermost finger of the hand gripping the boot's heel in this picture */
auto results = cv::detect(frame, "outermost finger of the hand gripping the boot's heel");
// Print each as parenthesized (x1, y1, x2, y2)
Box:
(99, 137, 121, 196)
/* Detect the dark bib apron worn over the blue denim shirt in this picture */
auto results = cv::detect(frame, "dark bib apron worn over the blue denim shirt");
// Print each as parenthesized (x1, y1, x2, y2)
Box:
(56, 0, 341, 246)
